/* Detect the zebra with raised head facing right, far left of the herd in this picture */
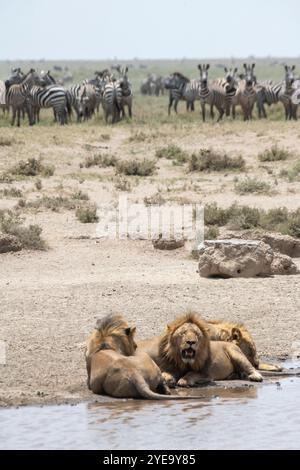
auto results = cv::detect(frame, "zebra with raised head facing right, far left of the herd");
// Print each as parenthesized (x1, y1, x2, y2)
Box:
(7, 69, 40, 127)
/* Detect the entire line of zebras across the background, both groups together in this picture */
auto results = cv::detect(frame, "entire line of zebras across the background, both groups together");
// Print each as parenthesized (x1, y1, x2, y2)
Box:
(0, 64, 300, 126)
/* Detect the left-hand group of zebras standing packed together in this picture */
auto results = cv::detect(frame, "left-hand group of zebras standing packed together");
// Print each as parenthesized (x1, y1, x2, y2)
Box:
(0, 67, 133, 126)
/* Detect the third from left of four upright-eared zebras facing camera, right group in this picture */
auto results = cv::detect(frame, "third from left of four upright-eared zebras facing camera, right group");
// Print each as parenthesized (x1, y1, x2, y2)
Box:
(233, 64, 257, 121)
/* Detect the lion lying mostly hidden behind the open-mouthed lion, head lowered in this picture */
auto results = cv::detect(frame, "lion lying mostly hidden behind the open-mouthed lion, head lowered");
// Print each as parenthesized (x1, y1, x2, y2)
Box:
(207, 320, 282, 372)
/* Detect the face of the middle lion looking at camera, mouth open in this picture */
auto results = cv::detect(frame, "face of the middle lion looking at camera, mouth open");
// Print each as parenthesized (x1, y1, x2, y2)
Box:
(171, 323, 206, 366)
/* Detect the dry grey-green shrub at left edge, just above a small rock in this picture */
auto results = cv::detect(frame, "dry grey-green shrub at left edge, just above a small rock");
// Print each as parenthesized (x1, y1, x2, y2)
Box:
(0, 211, 47, 251)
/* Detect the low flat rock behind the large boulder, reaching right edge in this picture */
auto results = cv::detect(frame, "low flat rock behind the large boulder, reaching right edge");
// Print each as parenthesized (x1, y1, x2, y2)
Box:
(223, 230, 300, 258)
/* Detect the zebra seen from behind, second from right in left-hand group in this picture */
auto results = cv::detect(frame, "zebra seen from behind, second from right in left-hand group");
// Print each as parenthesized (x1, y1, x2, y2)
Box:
(102, 80, 124, 124)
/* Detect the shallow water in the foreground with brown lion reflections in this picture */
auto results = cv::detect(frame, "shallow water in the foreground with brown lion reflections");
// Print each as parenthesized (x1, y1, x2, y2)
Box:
(0, 370, 300, 450)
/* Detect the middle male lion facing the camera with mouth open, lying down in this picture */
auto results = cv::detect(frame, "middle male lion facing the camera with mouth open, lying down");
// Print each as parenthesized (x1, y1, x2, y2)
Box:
(138, 312, 263, 387)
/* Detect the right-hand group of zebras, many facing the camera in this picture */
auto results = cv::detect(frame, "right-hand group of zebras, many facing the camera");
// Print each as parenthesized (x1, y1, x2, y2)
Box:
(165, 64, 300, 121)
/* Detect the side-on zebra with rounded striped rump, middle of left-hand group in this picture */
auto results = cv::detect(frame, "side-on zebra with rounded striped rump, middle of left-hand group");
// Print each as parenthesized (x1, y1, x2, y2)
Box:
(29, 80, 69, 125)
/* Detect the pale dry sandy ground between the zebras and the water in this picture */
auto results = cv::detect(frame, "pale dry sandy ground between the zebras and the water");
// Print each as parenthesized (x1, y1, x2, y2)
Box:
(0, 117, 300, 405)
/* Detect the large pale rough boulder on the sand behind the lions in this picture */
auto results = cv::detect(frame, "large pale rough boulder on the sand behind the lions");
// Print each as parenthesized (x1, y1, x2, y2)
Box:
(199, 239, 274, 279)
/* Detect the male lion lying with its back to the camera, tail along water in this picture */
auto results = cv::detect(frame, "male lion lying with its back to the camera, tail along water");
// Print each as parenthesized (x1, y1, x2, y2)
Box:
(86, 315, 205, 400)
